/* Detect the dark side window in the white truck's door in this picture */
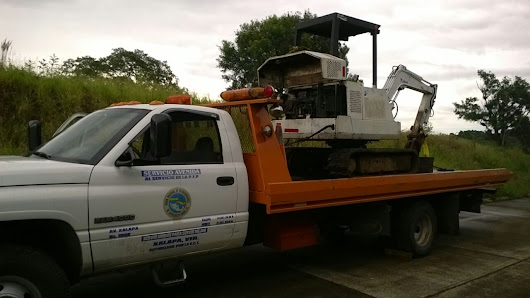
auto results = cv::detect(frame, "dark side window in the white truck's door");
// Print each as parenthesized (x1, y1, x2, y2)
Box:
(131, 111, 223, 165)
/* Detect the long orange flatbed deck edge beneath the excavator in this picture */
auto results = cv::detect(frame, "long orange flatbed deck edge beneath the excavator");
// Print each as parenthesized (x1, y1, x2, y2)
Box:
(258, 169, 512, 213)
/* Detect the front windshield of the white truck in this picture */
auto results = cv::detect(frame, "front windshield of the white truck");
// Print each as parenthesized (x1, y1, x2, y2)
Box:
(34, 108, 149, 165)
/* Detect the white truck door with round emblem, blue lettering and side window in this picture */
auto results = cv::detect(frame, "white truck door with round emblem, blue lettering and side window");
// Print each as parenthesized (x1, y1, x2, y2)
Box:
(89, 110, 237, 270)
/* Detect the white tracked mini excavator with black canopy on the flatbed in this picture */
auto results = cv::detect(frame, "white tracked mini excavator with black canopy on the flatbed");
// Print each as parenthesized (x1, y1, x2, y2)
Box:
(258, 13, 437, 179)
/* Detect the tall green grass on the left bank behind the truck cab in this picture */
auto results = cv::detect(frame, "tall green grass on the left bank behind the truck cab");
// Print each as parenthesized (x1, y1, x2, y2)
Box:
(0, 67, 208, 154)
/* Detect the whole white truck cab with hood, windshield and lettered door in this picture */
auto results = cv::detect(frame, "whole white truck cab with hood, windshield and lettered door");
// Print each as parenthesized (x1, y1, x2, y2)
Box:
(0, 104, 249, 275)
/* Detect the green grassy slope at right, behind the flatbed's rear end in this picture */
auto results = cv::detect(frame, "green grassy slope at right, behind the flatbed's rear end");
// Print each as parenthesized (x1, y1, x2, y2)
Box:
(369, 134, 530, 198)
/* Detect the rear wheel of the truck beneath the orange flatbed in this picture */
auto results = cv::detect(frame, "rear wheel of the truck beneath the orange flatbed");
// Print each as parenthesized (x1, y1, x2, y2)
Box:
(394, 201, 437, 257)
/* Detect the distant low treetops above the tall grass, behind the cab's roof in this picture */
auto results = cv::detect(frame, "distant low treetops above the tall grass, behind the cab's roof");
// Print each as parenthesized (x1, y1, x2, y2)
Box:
(62, 48, 178, 86)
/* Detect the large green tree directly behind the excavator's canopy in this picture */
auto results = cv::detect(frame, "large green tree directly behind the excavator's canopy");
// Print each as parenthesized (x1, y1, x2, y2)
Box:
(217, 11, 349, 89)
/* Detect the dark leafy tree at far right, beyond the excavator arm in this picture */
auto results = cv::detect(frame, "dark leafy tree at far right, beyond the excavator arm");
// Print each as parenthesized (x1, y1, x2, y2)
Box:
(453, 70, 530, 146)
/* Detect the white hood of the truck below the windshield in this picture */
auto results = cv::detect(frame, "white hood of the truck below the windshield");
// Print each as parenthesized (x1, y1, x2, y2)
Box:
(0, 156, 94, 187)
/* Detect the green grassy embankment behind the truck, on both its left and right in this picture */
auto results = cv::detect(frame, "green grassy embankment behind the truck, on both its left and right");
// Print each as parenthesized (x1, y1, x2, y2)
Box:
(0, 68, 530, 197)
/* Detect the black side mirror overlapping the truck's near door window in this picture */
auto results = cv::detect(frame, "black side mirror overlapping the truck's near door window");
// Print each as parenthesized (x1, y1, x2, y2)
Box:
(149, 114, 171, 158)
